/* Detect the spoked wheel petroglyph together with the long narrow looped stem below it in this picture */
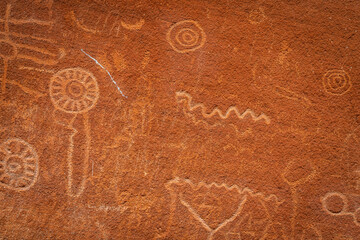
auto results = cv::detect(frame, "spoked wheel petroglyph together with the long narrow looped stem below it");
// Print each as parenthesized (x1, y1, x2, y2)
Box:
(49, 68, 99, 197)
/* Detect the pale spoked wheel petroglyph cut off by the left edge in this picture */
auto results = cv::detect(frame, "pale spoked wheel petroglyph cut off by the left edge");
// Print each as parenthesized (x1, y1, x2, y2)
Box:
(0, 138, 39, 191)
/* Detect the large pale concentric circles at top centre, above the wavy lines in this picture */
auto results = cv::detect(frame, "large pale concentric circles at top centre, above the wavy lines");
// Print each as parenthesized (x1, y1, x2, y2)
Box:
(166, 20, 206, 53)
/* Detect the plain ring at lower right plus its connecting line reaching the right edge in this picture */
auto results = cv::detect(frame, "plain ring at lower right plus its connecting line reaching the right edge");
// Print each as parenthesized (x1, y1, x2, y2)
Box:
(320, 192, 360, 227)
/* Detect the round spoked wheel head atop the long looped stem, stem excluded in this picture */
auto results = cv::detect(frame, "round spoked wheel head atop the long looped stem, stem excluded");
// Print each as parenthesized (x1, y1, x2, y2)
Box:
(50, 68, 99, 113)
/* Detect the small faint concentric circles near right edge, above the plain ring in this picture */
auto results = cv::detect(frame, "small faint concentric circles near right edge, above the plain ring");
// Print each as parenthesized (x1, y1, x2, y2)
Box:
(323, 69, 352, 95)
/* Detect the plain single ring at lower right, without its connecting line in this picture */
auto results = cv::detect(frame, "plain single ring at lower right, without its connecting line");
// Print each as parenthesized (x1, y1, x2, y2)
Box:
(321, 192, 348, 215)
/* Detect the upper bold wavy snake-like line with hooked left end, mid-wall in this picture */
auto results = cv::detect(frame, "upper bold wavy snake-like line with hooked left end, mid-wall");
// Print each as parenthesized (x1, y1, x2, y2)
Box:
(175, 92, 271, 124)
